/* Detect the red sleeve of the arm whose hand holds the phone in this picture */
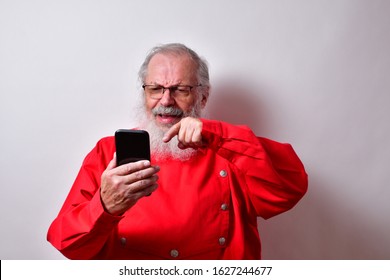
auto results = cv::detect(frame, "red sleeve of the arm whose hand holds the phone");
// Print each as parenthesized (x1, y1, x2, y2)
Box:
(47, 141, 121, 259)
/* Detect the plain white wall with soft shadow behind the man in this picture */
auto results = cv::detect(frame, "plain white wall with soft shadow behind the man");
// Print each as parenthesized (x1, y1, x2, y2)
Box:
(0, 0, 390, 259)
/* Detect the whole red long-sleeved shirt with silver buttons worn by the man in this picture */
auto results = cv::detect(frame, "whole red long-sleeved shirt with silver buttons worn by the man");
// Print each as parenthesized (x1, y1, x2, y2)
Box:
(48, 119, 307, 259)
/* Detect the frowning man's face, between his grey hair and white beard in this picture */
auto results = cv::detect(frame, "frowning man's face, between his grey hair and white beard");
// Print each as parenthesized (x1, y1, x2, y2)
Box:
(144, 54, 206, 128)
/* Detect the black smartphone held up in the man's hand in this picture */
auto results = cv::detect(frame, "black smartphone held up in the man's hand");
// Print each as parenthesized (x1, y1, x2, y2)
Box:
(115, 129, 150, 166)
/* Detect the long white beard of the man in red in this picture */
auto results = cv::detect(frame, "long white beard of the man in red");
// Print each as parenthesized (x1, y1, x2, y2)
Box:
(138, 100, 201, 161)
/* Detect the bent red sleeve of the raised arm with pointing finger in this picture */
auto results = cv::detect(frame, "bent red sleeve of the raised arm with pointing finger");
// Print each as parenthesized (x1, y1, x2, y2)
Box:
(202, 119, 308, 219)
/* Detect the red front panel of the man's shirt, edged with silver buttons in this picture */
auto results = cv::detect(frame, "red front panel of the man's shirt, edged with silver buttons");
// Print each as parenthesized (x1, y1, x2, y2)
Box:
(112, 152, 244, 258)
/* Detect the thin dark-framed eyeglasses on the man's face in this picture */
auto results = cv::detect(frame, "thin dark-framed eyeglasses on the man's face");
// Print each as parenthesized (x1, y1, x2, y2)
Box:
(142, 84, 202, 100)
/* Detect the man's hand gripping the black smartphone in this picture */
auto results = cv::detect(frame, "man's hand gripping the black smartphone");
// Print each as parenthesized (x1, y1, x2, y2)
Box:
(100, 155, 160, 215)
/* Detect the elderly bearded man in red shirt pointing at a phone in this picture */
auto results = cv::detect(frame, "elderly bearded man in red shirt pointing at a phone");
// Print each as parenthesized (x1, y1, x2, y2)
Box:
(48, 44, 307, 259)
